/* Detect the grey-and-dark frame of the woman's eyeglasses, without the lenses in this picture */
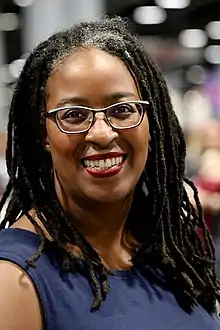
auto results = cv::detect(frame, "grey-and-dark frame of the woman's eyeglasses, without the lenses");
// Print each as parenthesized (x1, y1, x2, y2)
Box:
(46, 100, 150, 134)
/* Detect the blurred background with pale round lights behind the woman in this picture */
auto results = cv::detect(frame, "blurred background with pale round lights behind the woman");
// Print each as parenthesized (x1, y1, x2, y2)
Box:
(0, 0, 220, 274)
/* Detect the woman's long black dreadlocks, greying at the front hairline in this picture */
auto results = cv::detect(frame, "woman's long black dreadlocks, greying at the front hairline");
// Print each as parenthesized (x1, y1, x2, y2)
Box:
(0, 17, 220, 313)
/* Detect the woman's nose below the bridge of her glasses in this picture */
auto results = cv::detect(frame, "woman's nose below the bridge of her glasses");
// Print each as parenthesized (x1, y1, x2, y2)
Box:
(85, 113, 118, 148)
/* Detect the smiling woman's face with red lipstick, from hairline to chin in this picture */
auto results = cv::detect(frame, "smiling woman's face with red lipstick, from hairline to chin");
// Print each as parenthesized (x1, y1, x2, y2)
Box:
(46, 48, 149, 203)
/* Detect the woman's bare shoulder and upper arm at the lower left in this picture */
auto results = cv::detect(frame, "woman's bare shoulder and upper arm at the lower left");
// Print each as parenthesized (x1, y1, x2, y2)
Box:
(0, 260, 43, 330)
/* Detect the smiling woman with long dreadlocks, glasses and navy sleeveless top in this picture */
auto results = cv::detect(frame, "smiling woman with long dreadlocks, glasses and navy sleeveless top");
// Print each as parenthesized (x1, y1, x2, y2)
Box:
(0, 18, 220, 330)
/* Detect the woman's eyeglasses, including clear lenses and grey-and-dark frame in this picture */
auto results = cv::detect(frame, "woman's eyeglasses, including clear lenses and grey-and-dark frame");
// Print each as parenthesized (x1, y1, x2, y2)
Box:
(46, 101, 149, 134)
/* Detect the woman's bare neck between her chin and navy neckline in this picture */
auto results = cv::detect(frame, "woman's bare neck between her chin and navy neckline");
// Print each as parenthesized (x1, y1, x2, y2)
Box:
(55, 182, 137, 269)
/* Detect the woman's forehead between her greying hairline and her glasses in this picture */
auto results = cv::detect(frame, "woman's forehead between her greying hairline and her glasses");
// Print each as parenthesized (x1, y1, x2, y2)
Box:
(47, 48, 138, 105)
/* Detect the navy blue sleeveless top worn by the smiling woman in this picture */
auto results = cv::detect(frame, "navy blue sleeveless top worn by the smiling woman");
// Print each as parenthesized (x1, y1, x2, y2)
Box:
(0, 229, 220, 330)
